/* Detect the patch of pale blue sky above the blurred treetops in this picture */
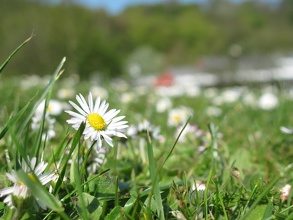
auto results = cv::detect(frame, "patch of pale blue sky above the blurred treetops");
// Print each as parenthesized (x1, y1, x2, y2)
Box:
(70, 0, 280, 14)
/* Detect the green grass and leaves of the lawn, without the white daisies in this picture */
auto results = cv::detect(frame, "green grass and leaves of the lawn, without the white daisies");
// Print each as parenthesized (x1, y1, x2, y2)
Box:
(0, 40, 293, 220)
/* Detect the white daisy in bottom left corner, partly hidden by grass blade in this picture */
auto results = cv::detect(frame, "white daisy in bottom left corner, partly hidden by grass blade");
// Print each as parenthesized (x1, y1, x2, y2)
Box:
(0, 157, 55, 210)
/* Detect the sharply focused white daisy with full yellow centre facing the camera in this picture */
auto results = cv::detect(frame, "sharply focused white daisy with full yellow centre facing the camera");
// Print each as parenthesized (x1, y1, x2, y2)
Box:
(65, 93, 128, 149)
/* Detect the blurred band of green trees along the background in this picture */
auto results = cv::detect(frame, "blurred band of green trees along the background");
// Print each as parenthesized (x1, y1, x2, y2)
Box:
(0, 0, 293, 78)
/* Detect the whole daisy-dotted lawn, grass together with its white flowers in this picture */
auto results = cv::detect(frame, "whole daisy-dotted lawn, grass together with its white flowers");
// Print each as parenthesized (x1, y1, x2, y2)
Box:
(0, 38, 293, 220)
